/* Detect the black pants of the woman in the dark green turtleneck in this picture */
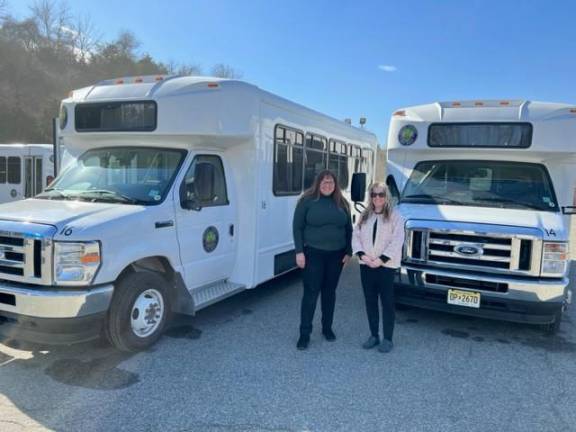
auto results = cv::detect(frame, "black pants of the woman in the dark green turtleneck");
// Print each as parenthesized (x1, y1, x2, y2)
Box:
(300, 248, 345, 335)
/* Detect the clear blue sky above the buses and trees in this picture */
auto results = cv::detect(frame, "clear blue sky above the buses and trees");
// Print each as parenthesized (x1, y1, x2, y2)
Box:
(8, 0, 576, 144)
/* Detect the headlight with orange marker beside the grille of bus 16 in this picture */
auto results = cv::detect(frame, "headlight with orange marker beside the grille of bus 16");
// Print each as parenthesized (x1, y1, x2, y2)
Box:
(54, 241, 100, 285)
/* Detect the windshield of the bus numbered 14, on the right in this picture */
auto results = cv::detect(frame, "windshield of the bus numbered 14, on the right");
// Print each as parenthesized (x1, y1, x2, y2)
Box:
(400, 160, 558, 212)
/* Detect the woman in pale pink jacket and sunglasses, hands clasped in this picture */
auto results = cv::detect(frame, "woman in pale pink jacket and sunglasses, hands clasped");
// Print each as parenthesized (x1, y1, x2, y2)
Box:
(352, 183, 404, 353)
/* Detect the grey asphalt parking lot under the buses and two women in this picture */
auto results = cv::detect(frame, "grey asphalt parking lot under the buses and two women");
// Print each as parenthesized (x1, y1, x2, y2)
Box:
(0, 253, 576, 432)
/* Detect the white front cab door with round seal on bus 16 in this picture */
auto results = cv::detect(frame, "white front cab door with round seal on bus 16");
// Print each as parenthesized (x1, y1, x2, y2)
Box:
(176, 154, 238, 289)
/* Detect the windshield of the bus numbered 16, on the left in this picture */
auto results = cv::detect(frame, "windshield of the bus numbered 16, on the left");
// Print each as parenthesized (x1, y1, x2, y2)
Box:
(36, 147, 186, 205)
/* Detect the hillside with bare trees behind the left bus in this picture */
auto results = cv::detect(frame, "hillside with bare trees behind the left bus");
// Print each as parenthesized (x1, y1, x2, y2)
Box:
(0, 0, 239, 143)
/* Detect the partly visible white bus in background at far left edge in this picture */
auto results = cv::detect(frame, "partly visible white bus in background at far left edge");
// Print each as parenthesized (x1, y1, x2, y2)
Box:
(0, 144, 54, 203)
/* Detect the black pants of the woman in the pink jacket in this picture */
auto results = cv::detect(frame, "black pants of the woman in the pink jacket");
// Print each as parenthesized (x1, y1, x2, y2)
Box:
(360, 265, 396, 341)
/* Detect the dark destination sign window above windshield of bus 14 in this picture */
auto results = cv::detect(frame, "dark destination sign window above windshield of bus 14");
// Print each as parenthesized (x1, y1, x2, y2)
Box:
(428, 123, 532, 148)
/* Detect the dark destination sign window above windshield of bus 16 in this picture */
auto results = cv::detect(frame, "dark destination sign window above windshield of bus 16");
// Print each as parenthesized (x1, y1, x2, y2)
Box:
(75, 101, 157, 132)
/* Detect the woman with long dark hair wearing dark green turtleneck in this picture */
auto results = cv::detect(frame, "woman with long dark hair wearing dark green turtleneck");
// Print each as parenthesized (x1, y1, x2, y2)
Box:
(293, 170, 352, 350)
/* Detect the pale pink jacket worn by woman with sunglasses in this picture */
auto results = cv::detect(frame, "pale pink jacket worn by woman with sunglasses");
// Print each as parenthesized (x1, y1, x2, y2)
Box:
(352, 210, 404, 268)
